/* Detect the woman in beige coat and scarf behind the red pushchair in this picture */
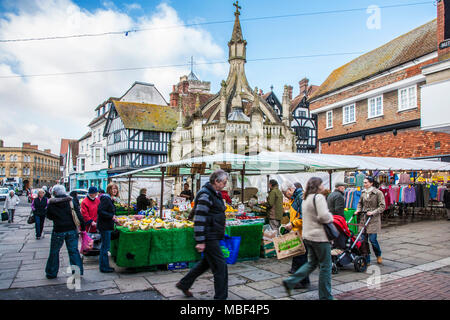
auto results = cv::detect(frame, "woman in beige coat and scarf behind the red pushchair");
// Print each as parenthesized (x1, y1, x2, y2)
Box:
(355, 177, 386, 265)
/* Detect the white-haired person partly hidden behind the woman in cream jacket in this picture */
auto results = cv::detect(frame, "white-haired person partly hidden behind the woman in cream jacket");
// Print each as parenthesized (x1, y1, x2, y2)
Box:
(281, 182, 310, 289)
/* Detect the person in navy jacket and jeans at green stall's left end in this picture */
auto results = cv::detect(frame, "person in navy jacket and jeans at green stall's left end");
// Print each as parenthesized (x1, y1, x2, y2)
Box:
(97, 183, 119, 273)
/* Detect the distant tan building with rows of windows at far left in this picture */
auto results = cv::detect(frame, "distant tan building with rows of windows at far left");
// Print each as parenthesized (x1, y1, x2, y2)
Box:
(0, 140, 60, 188)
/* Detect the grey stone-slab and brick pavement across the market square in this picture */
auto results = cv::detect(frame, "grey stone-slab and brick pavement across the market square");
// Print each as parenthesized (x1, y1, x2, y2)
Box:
(0, 197, 450, 300)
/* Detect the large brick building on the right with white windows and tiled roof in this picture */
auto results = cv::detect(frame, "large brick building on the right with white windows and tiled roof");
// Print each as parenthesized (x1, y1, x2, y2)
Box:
(309, 1, 450, 160)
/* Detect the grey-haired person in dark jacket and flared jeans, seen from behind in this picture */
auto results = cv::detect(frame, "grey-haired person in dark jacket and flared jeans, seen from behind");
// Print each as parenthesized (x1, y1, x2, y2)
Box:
(45, 185, 85, 279)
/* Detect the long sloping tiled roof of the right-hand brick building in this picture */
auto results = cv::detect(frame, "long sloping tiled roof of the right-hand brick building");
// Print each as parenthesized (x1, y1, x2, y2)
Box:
(310, 19, 437, 99)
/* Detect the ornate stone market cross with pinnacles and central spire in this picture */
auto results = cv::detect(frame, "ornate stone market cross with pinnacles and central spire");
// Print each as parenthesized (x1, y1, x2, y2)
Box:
(170, 2, 295, 161)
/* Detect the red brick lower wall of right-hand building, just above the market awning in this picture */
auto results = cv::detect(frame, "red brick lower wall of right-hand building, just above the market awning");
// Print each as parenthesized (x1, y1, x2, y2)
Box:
(322, 127, 450, 158)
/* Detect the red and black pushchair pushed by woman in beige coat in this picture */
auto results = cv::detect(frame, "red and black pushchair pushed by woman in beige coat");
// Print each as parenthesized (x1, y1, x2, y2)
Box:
(331, 212, 372, 274)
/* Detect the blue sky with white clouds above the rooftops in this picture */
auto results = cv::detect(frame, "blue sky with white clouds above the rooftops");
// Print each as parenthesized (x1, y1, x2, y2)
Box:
(0, 0, 436, 154)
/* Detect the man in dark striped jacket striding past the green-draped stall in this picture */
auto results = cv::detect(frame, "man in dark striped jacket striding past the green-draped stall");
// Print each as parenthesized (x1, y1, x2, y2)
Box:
(176, 170, 228, 300)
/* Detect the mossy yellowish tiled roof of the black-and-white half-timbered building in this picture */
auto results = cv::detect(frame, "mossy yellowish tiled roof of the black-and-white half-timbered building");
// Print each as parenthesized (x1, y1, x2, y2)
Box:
(113, 101, 178, 132)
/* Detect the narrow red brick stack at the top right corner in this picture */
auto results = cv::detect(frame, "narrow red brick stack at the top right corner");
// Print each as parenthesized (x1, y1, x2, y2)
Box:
(437, 0, 450, 61)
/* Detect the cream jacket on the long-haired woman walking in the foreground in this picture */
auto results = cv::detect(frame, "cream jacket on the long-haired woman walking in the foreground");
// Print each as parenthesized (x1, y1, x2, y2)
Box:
(302, 194, 333, 242)
